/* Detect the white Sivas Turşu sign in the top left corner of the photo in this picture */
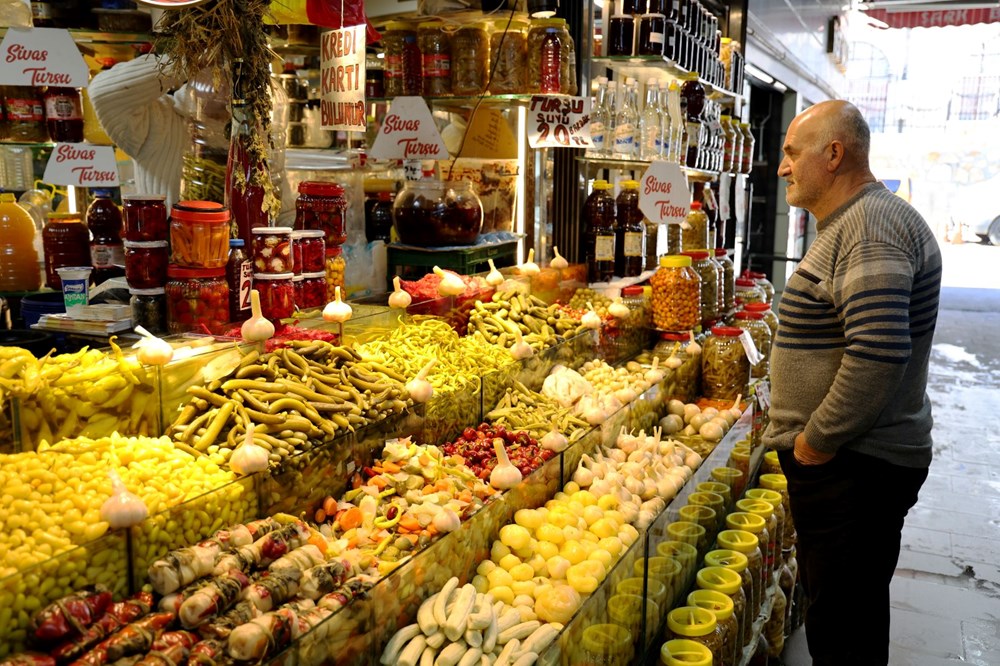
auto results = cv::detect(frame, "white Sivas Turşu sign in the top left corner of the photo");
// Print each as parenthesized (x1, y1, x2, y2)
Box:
(0, 28, 89, 88)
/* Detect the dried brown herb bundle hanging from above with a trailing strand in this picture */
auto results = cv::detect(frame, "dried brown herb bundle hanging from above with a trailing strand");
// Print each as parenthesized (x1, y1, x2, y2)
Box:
(156, 0, 280, 217)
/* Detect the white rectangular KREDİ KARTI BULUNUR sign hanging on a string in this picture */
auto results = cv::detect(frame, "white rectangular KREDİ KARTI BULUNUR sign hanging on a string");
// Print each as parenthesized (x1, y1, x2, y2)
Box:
(320, 25, 367, 132)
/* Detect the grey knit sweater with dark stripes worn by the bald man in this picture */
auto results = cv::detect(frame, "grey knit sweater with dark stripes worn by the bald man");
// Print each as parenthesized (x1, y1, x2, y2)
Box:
(764, 183, 941, 468)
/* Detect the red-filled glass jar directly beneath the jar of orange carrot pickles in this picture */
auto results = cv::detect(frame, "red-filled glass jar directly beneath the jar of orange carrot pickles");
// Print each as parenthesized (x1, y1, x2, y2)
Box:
(166, 266, 229, 335)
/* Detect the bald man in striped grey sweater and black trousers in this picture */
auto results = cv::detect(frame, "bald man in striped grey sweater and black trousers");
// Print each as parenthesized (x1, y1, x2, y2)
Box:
(764, 101, 941, 666)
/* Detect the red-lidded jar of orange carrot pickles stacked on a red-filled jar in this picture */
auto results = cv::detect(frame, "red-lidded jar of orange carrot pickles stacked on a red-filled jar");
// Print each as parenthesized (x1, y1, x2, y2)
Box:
(170, 201, 229, 268)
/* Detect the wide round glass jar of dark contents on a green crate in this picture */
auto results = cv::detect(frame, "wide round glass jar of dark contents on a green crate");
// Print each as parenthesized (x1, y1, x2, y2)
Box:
(392, 180, 483, 247)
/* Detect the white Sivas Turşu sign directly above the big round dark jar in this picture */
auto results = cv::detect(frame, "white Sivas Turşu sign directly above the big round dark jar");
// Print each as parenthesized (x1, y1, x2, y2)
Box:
(368, 97, 448, 160)
